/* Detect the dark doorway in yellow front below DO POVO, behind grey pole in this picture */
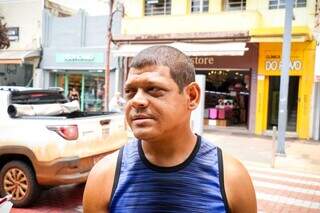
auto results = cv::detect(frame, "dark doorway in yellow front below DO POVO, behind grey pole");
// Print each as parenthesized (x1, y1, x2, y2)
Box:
(268, 76, 299, 132)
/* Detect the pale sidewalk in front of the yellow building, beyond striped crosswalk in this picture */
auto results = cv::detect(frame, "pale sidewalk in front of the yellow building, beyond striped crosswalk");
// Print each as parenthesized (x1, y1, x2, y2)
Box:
(203, 130, 320, 175)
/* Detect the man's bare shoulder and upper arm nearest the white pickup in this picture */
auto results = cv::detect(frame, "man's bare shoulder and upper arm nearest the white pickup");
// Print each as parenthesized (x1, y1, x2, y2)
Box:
(82, 151, 119, 213)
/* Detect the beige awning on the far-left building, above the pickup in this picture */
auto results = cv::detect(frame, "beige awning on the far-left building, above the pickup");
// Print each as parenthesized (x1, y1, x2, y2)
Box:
(0, 50, 40, 64)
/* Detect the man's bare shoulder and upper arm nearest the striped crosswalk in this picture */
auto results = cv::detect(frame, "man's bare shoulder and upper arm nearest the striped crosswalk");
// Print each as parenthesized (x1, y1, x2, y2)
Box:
(223, 154, 257, 213)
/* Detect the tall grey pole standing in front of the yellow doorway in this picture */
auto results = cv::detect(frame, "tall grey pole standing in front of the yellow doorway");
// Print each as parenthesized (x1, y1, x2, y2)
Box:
(277, 0, 293, 155)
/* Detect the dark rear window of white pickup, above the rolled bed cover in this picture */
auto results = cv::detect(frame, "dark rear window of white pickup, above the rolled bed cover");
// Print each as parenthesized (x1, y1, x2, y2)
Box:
(11, 90, 68, 104)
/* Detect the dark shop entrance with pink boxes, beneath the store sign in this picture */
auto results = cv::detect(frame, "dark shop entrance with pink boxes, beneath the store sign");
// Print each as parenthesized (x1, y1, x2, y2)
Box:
(197, 69, 251, 128)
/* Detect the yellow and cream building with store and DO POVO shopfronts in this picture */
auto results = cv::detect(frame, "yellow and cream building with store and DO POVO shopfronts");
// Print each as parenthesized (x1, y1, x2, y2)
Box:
(115, 0, 316, 138)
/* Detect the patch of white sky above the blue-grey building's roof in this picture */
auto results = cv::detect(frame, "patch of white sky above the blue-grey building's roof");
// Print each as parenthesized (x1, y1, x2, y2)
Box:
(50, 0, 108, 15)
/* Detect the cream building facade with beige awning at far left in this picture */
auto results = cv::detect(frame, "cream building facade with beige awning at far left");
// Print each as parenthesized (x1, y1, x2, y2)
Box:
(0, 0, 72, 86)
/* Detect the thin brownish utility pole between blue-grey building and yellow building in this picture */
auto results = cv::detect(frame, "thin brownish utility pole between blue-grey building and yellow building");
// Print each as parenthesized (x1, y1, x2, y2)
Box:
(104, 0, 114, 111)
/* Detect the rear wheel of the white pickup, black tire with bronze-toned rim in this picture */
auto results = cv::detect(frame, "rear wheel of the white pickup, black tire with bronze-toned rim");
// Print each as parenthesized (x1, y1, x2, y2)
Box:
(0, 160, 40, 208)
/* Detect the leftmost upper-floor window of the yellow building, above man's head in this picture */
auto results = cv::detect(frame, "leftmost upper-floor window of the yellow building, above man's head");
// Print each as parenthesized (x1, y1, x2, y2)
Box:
(144, 0, 171, 16)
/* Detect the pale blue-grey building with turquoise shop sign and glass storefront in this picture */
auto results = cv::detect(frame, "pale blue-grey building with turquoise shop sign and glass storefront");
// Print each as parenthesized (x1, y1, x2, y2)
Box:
(39, 10, 122, 111)
